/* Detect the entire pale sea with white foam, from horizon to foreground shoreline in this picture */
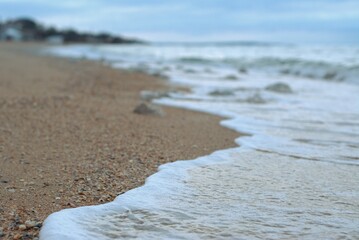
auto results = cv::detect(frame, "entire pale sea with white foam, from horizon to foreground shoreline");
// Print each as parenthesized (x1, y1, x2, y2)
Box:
(40, 42, 359, 240)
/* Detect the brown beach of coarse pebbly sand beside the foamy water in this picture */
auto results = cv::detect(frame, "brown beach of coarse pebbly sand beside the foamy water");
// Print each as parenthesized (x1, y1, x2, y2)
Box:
(0, 43, 238, 239)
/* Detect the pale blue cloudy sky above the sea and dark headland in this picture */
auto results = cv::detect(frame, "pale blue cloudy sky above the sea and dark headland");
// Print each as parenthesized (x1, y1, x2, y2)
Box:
(0, 0, 359, 44)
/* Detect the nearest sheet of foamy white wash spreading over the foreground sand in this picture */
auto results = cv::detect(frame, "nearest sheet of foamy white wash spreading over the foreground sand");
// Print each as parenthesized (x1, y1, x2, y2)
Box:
(41, 148, 359, 239)
